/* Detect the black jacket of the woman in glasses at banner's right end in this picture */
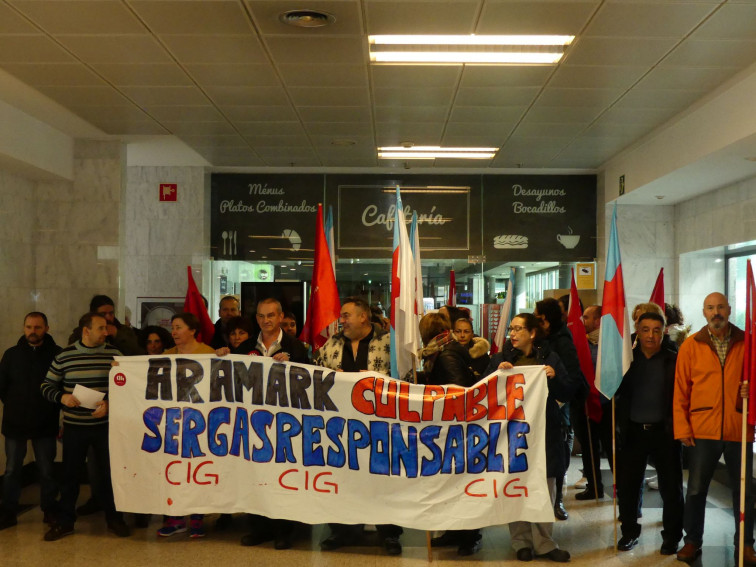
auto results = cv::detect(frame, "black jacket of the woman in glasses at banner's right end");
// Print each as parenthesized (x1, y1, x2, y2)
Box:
(485, 339, 585, 478)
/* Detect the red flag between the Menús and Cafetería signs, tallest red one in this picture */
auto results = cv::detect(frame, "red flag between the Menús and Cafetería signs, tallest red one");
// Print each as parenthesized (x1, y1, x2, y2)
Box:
(299, 203, 341, 351)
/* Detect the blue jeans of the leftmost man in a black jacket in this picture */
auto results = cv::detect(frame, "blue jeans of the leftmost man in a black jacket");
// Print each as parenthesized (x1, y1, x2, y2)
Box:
(3, 437, 58, 514)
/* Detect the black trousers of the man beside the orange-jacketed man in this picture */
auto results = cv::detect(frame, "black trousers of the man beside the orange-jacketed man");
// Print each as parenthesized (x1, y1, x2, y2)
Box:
(617, 422, 685, 542)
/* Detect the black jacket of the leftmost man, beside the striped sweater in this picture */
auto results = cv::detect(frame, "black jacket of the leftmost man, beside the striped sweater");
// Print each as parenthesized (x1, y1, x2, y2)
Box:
(0, 334, 61, 439)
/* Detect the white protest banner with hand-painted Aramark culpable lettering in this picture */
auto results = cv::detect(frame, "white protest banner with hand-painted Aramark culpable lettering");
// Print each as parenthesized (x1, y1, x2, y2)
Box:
(109, 355, 554, 530)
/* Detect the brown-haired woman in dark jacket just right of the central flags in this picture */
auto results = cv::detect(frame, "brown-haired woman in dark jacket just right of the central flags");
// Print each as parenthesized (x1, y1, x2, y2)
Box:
(420, 313, 481, 556)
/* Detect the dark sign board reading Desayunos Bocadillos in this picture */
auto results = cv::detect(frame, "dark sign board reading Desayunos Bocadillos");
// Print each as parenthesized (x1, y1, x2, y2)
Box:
(483, 175, 596, 262)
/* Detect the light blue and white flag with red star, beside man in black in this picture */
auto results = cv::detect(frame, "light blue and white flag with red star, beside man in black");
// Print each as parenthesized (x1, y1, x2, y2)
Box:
(596, 203, 633, 398)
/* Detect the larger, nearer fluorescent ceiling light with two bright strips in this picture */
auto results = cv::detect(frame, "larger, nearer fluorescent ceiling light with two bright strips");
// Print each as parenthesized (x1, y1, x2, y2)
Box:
(368, 35, 575, 65)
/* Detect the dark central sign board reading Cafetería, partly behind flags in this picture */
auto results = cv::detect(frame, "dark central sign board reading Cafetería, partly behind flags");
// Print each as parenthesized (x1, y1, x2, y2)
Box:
(326, 175, 480, 259)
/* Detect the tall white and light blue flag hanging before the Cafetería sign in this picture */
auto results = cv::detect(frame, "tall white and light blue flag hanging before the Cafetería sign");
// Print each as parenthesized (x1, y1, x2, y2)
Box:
(391, 186, 421, 379)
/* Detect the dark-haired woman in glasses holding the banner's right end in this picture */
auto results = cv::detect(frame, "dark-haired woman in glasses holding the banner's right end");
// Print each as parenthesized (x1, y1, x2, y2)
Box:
(486, 313, 576, 563)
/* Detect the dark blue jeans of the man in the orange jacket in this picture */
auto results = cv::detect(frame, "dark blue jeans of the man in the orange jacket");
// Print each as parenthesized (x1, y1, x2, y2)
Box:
(683, 439, 753, 546)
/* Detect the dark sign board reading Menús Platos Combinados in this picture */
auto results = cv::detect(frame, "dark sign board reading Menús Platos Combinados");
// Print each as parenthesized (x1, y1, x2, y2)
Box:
(210, 173, 324, 261)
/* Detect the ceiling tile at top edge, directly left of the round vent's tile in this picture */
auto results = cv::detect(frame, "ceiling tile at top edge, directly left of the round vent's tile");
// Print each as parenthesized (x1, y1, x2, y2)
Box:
(130, 0, 251, 35)
